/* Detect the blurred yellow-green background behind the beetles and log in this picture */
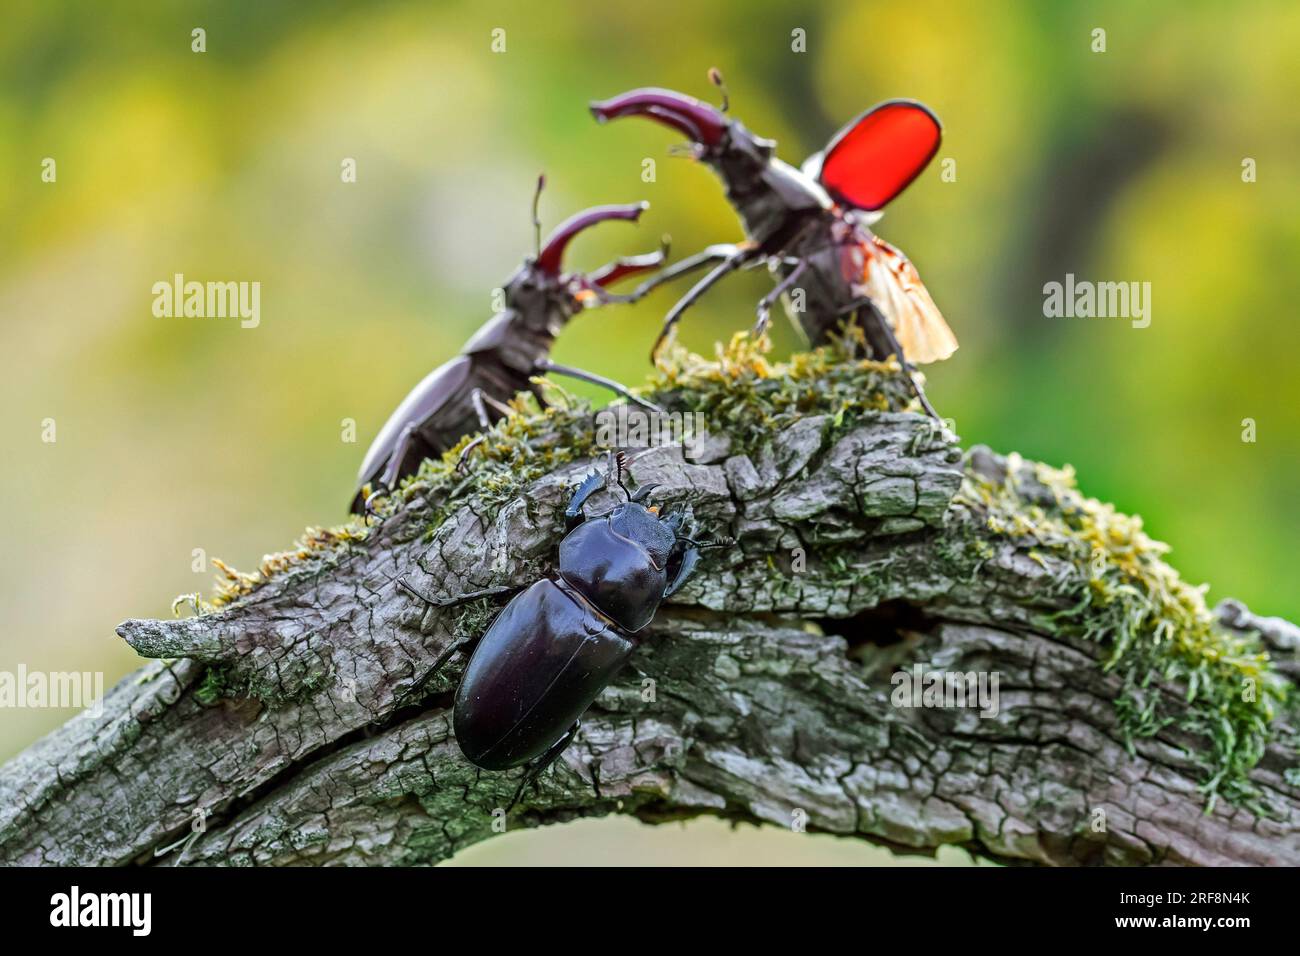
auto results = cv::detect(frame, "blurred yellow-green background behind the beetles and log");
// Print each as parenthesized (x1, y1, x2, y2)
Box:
(0, 0, 1300, 862)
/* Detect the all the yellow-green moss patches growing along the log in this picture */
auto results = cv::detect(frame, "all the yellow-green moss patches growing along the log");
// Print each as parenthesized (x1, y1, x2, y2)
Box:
(178, 336, 1286, 806)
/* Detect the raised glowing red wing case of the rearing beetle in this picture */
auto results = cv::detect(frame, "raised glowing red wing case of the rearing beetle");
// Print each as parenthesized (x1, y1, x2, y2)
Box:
(805, 100, 943, 211)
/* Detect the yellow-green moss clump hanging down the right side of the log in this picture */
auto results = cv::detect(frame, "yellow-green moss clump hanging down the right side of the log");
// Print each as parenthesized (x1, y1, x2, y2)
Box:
(958, 455, 1287, 809)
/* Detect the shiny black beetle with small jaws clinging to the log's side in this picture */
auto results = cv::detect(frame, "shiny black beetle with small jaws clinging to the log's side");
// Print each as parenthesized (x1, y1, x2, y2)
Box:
(399, 453, 727, 806)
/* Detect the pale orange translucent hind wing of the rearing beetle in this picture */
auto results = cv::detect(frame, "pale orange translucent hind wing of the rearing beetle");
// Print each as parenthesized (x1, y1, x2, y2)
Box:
(862, 235, 957, 364)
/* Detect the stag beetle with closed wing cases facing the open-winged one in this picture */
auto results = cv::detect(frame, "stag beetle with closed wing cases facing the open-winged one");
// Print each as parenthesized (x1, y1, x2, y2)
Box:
(351, 177, 667, 514)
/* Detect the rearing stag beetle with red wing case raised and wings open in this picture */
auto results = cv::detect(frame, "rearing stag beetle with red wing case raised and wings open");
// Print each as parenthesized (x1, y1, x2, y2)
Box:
(590, 70, 957, 418)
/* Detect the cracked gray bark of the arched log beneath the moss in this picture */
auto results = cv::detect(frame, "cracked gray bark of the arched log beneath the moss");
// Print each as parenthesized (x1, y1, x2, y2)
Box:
(0, 414, 1300, 865)
